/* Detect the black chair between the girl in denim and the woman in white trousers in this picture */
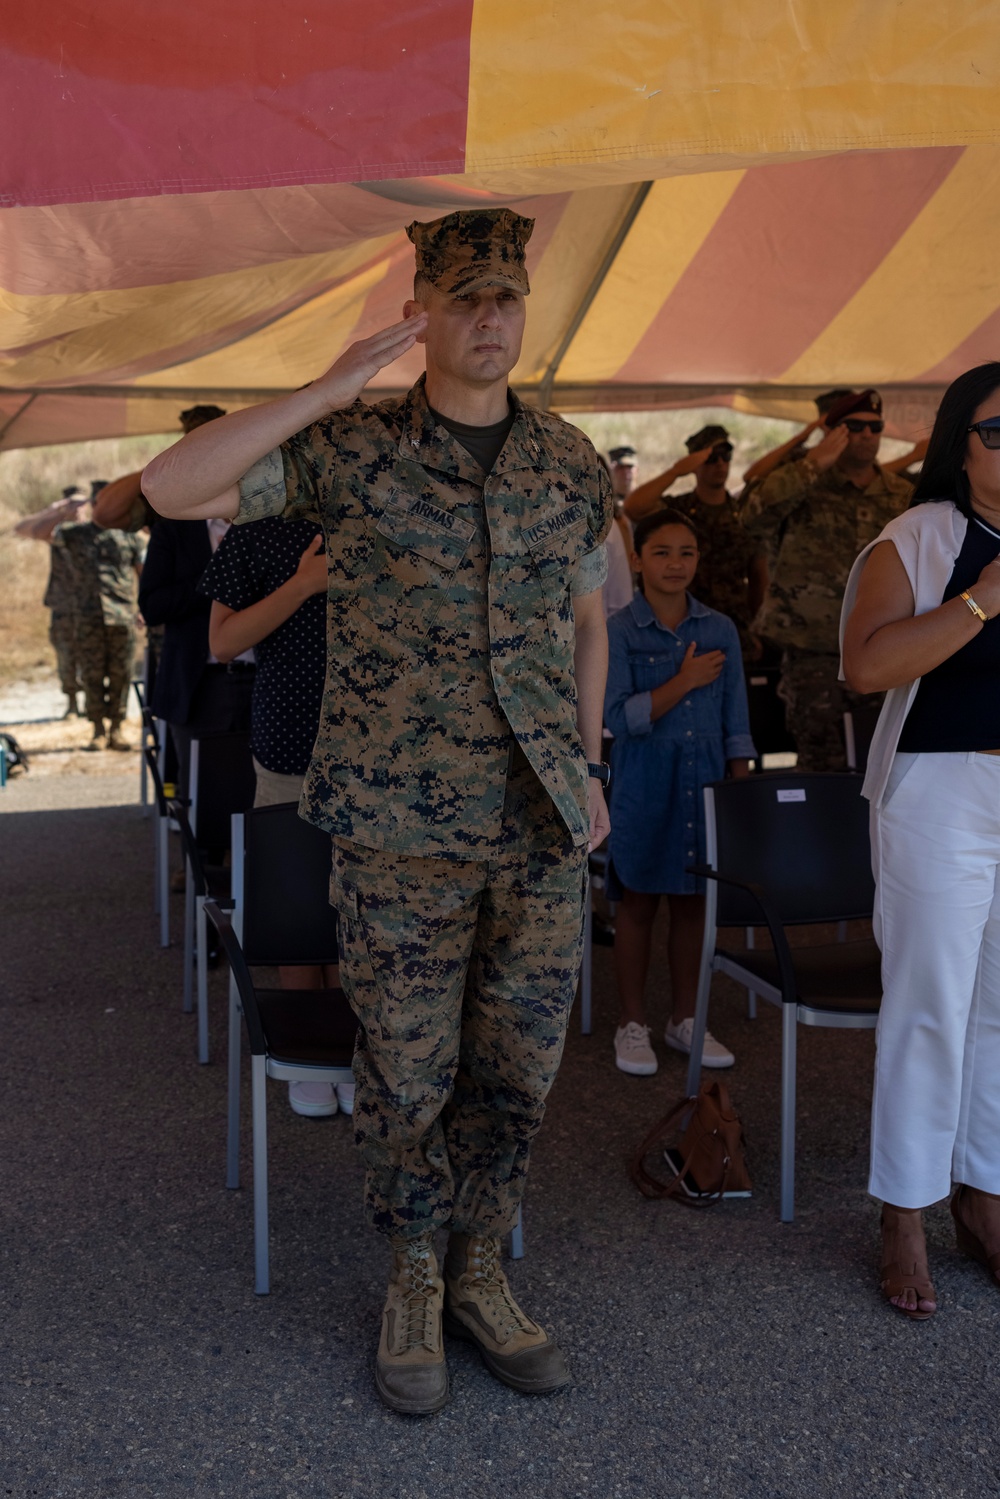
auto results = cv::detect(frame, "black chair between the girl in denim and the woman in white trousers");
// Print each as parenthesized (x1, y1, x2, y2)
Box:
(688, 772, 882, 1223)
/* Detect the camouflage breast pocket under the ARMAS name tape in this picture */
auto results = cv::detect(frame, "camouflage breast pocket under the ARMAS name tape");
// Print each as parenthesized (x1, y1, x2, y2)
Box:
(355, 498, 475, 643)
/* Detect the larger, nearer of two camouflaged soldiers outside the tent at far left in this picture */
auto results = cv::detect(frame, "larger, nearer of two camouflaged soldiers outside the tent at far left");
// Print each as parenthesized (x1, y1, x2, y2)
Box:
(52, 520, 145, 750)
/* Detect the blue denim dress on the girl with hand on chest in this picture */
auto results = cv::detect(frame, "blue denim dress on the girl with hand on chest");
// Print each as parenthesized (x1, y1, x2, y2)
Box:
(604, 594, 754, 899)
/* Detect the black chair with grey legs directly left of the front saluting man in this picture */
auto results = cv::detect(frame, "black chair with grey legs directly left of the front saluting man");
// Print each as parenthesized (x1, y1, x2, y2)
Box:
(205, 802, 357, 1295)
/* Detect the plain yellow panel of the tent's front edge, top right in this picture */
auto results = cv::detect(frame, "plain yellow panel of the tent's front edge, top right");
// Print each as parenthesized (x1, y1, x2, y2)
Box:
(466, 0, 1000, 186)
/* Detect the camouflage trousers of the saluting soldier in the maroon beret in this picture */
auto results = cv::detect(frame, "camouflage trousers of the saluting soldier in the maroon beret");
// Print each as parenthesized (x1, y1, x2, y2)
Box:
(778, 648, 883, 770)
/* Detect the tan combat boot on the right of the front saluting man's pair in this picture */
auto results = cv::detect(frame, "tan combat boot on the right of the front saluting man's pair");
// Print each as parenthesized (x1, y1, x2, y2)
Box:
(444, 1234, 570, 1396)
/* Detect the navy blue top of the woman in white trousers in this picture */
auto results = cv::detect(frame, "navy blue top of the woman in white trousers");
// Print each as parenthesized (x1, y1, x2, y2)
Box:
(897, 516, 1000, 752)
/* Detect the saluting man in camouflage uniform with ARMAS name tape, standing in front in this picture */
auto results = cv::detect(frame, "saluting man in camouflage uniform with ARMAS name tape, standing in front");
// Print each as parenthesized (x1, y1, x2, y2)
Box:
(144, 210, 612, 1414)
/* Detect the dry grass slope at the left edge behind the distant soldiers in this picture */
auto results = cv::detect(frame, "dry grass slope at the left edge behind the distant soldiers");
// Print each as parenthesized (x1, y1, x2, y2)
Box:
(0, 435, 177, 687)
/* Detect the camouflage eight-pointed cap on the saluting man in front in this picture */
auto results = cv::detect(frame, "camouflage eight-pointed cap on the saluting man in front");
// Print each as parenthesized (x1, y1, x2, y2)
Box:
(406, 208, 535, 297)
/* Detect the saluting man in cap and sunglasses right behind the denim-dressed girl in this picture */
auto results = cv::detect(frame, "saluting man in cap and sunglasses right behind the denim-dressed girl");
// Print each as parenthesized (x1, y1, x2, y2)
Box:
(625, 424, 768, 660)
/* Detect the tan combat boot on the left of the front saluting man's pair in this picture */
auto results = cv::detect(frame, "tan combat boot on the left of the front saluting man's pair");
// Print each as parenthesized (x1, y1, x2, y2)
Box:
(375, 1234, 448, 1415)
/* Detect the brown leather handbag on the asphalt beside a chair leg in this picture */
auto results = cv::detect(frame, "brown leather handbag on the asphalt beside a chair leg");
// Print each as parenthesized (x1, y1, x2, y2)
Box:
(628, 1079, 751, 1208)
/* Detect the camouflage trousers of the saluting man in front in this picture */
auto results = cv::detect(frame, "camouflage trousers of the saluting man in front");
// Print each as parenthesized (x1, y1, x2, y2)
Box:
(333, 824, 588, 1238)
